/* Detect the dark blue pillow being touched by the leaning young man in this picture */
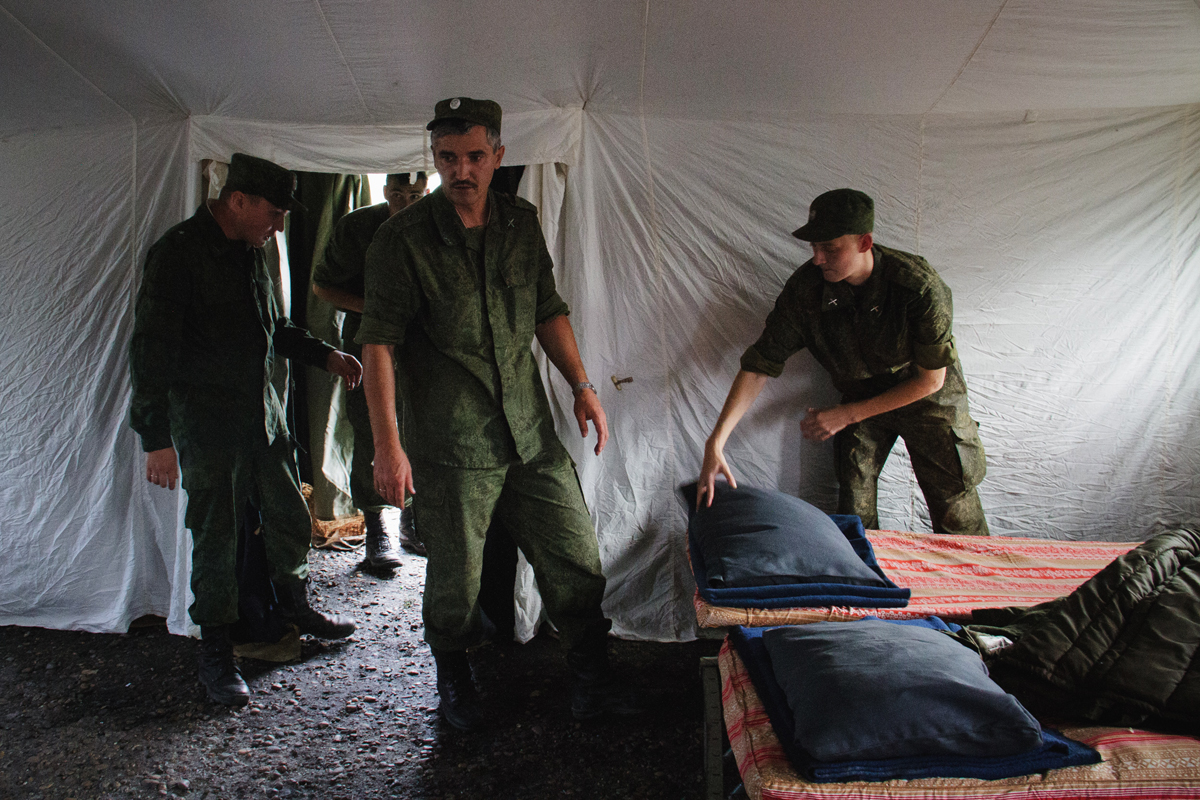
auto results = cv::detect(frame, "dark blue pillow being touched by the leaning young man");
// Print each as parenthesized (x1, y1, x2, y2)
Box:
(679, 482, 892, 589)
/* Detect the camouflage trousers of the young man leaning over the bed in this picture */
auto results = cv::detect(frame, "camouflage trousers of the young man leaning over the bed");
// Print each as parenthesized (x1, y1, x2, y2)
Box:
(834, 395, 989, 536)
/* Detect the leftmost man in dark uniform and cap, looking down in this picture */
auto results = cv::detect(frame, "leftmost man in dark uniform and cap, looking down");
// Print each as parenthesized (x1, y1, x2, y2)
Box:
(130, 154, 362, 705)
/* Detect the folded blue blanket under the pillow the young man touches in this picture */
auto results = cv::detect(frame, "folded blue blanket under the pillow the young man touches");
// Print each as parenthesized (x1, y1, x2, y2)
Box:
(688, 515, 912, 608)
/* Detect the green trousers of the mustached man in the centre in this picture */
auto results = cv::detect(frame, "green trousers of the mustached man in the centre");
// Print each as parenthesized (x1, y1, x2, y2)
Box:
(413, 441, 611, 650)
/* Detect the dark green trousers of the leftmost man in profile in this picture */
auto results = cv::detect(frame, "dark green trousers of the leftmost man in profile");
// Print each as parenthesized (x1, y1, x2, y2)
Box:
(180, 435, 312, 625)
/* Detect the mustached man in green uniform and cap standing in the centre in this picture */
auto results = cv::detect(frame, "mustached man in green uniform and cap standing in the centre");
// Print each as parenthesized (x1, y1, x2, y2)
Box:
(359, 97, 638, 730)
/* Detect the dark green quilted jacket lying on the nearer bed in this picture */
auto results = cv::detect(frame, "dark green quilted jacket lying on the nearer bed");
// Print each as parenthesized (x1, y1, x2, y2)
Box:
(967, 529, 1200, 735)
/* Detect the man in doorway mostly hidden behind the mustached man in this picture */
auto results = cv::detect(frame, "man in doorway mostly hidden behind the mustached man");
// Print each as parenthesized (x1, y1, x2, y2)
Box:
(312, 173, 426, 570)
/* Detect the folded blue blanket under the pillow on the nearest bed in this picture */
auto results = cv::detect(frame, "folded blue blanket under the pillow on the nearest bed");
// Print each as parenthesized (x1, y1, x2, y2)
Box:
(730, 616, 1100, 783)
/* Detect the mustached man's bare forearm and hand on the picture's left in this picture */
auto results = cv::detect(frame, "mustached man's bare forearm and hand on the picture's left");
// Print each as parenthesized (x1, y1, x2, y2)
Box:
(362, 344, 416, 509)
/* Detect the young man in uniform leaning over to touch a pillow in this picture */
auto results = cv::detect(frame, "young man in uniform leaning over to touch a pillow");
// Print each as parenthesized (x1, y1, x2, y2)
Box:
(697, 190, 988, 535)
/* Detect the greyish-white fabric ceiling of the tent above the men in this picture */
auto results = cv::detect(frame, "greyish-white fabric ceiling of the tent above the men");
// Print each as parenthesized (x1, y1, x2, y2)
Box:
(0, 0, 1200, 132)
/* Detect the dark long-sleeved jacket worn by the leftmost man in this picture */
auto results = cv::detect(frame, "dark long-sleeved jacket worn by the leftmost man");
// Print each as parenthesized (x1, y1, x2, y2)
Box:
(130, 206, 334, 452)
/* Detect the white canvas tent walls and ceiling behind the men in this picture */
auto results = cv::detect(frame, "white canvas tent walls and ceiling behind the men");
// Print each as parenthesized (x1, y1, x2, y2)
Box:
(0, 0, 1200, 639)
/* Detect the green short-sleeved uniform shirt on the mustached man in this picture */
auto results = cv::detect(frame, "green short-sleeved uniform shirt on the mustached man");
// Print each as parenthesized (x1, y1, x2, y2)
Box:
(358, 188, 568, 468)
